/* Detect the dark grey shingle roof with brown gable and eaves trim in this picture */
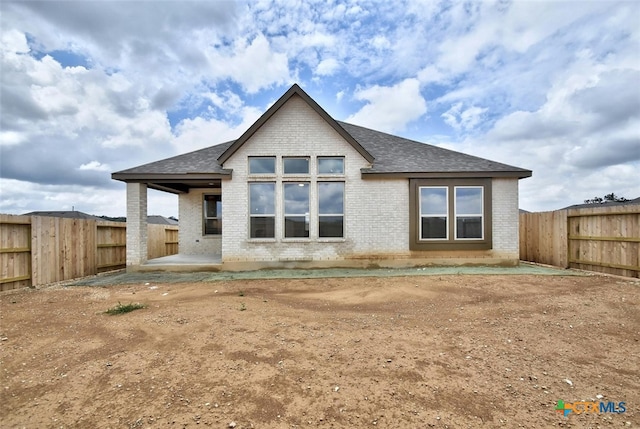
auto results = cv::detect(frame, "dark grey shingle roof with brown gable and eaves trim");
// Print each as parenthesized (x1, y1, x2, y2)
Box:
(112, 85, 531, 182)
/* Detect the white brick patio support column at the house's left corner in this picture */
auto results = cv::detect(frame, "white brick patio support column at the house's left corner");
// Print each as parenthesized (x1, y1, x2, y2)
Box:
(127, 183, 147, 269)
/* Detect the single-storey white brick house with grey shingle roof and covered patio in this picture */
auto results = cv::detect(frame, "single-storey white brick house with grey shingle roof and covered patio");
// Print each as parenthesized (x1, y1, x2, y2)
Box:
(112, 85, 532, 270)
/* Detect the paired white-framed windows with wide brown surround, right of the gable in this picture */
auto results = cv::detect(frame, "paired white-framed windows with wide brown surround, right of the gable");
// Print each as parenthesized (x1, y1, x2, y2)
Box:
(409, 178, 492, 250)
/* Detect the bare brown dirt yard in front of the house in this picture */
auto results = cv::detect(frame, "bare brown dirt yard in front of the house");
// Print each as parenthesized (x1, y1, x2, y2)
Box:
(0, 275, 640, 428)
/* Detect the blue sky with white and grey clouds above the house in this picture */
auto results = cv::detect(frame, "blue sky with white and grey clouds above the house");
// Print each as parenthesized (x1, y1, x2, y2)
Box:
(0, 0, 640, 217)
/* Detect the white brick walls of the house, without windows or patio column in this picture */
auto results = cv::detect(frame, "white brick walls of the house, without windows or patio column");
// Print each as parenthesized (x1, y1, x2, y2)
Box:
(179, 96, 519, 265)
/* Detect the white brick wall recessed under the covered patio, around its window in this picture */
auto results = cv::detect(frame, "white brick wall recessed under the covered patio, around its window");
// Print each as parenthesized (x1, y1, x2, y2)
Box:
(178, 189, 225, 255)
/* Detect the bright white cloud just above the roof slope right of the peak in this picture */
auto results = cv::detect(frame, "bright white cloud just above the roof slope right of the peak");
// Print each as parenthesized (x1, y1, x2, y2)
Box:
(346, 79, 427, 132)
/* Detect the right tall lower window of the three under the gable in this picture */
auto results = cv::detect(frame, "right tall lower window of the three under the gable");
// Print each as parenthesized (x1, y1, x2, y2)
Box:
(318, 182, 344, 238)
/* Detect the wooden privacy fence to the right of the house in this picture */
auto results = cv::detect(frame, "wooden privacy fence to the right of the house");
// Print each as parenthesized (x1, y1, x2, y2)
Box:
(520, 205, 640, 277)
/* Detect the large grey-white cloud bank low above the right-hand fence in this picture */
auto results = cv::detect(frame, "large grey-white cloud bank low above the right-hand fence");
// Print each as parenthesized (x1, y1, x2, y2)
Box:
(463, 52, 640, 210)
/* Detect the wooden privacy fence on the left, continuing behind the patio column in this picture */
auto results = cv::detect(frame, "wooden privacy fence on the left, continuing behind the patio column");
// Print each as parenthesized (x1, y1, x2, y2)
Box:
(0, 215, 178, 291)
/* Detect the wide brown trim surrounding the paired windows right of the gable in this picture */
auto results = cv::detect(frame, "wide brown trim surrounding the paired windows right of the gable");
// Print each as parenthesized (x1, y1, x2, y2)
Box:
(409, 178, 493, 250)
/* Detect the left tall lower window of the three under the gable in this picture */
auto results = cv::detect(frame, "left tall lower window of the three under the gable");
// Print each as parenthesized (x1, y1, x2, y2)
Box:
(249, 183, 276, 238)
